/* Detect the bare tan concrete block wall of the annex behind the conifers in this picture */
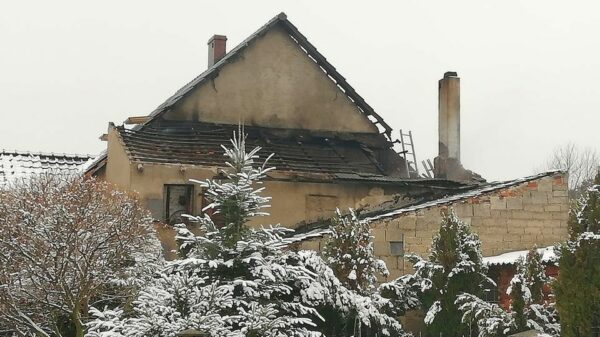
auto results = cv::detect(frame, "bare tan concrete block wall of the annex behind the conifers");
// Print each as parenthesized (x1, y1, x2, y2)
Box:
(372, 173, 569, 279)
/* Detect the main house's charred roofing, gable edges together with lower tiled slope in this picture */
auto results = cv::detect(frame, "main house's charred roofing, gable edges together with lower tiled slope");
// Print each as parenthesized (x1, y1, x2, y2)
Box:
(86, 13, 406, 176)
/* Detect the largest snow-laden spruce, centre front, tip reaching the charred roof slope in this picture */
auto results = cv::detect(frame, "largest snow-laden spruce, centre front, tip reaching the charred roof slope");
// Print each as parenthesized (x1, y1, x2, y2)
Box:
(89, 135, 412, 337)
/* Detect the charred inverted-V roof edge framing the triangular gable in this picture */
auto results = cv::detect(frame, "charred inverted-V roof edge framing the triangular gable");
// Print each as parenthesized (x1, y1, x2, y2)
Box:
(145, 12, 392, 138)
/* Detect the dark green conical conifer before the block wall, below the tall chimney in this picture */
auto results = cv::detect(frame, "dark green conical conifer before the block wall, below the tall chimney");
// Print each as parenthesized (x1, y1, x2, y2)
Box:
(409, 209, 493, 336)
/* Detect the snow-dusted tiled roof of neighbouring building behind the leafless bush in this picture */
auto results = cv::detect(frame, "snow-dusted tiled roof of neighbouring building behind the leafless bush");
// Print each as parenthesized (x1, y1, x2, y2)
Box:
(0, 150, 92, 188)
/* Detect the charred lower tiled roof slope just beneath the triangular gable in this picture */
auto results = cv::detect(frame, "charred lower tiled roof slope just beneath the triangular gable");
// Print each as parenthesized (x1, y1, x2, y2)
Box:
(116, 121, 400, 179)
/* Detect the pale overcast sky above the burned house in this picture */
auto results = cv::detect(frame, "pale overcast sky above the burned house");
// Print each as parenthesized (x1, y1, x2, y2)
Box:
(0, 0, 600, 180)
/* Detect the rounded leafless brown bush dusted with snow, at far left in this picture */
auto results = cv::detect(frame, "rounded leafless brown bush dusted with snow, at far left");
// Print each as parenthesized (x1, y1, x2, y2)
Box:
(0, 174, 160, 336)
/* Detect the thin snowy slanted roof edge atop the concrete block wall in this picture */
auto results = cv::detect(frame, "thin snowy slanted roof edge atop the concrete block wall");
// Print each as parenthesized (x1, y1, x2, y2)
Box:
(366, 170, 563, 221)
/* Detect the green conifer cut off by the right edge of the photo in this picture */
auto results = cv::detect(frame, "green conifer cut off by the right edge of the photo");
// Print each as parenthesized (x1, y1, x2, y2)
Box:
(553, 174, 600, 337)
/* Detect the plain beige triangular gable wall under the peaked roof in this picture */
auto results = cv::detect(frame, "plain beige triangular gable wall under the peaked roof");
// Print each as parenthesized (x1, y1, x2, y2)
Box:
(165, 27, 378, 132)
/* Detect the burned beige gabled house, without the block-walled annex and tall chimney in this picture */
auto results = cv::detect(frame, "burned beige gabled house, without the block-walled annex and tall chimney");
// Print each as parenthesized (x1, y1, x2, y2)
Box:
(83, 14, 474, 231)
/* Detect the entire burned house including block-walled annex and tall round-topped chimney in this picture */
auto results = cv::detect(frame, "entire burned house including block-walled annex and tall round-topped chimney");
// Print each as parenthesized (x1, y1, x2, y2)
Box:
(82, 13, 568, 288)
